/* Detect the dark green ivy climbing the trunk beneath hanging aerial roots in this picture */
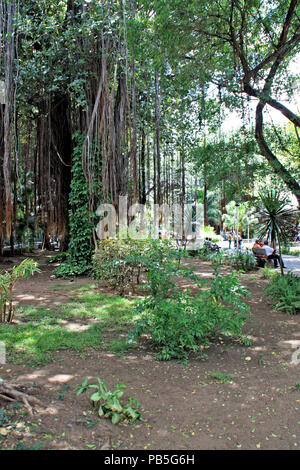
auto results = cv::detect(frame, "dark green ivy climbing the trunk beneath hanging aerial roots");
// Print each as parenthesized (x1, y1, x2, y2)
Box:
(54, 135, 93, 278)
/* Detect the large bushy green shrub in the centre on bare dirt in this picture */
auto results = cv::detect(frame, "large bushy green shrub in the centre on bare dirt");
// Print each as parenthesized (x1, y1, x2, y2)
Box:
(130, 264, 249, 360)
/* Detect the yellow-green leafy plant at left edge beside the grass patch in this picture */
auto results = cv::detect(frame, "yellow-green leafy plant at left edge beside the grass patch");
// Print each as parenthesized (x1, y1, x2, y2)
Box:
(0, 258, 40, 323)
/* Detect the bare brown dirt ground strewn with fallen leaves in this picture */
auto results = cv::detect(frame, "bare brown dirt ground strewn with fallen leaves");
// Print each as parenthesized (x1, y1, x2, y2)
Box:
(0, 252, 300, 450)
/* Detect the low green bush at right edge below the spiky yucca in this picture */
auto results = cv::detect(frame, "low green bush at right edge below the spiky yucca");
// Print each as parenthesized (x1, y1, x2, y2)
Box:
(265, 273, 300, 315)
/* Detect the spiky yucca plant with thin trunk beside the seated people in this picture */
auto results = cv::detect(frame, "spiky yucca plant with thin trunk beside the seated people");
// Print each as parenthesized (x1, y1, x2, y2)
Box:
(259, 189, 299, 275)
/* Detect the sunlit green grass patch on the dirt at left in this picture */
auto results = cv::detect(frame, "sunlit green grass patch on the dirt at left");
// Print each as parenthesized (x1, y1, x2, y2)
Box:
(0, 286, 136, 365)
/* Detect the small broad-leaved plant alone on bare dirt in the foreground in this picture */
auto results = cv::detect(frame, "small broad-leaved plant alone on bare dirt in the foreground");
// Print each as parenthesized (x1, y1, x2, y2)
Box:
(76, 378, 141, 424)
